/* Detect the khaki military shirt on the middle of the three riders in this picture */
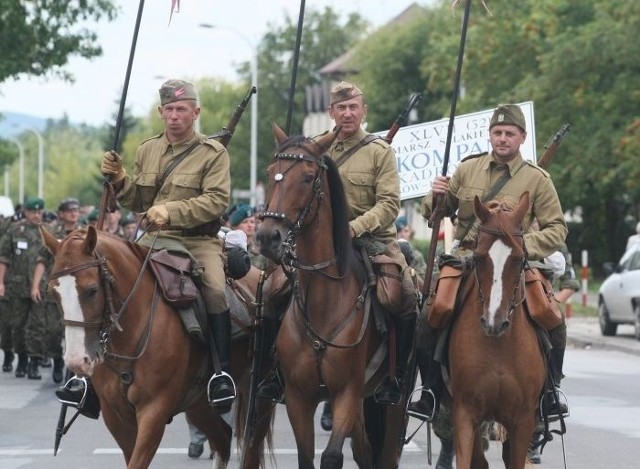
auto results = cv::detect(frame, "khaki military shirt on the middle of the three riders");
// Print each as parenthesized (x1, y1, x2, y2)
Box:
(329, 129, 400, 243)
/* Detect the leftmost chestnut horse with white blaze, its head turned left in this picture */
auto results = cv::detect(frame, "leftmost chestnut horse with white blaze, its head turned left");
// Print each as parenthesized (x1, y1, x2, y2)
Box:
(41, 226, 273, 469)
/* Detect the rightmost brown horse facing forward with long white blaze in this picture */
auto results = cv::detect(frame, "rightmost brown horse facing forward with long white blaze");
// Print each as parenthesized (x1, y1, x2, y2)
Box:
(449, 192, 546, 469)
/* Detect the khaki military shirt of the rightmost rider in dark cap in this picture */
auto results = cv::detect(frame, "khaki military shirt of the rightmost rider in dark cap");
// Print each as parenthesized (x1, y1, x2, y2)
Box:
(422, 153, 568, 260)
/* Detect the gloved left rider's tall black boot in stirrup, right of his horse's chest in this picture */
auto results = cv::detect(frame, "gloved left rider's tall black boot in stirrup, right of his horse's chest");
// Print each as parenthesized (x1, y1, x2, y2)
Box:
(207, 310, 236, 414)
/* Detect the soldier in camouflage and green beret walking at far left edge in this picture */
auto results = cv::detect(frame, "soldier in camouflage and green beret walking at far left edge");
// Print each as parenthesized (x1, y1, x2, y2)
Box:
(0, 197, 46, 379)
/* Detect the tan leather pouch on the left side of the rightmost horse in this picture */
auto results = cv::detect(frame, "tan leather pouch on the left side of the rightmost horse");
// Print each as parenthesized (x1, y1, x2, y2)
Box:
(426, 265, 463, 329)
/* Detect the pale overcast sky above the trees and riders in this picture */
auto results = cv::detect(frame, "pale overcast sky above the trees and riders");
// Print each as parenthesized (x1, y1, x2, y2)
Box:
(0, 0, 429, 126)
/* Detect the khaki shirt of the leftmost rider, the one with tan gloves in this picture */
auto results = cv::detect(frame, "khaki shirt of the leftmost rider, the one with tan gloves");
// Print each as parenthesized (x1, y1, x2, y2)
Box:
(118, 132, 231, 229)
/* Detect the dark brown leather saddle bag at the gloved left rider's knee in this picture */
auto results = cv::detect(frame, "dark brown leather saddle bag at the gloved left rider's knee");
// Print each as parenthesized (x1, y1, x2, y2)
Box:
(149, 249, 199, 309)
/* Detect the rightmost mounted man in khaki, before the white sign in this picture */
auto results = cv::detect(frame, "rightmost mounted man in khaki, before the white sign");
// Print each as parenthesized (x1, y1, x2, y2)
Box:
(416, 104, 567, 417)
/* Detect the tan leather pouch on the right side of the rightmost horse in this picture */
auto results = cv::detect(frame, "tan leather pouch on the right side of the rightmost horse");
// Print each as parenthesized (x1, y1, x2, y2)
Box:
(524, 269, 562, 331)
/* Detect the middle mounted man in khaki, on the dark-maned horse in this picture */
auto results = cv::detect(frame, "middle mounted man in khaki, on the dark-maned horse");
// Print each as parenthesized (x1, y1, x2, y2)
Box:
(258, 81, 416, 405)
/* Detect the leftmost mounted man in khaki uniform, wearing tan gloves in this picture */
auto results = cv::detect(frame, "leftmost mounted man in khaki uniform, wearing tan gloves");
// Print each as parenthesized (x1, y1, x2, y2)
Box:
(96, 76, 235, 413)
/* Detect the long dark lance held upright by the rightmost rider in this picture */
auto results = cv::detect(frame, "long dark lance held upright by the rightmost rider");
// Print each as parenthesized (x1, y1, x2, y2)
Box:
(421, 0, 471, 309)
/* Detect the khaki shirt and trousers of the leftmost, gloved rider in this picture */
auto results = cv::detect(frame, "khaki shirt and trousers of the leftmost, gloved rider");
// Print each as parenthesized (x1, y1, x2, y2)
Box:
(117, 133, 230, 314)
